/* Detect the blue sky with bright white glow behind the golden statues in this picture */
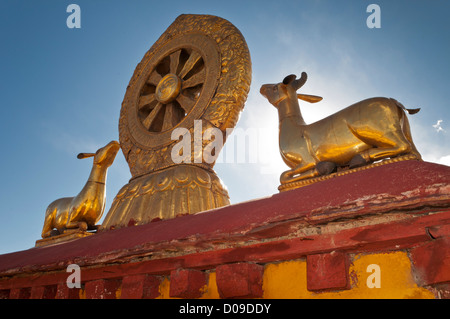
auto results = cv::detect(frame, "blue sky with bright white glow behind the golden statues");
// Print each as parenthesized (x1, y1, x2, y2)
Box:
(0, 0, 450, 254)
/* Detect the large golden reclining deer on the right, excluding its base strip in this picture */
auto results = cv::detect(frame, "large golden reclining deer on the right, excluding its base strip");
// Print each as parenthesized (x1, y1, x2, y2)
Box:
(260, 72, 421, 184)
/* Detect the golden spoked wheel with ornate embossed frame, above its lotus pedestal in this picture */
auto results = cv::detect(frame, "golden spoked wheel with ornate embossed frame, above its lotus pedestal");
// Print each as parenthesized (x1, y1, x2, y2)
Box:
(119, 15, 251, 176)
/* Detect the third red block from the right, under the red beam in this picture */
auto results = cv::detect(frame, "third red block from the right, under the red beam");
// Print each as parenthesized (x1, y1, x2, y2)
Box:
(216, 263, 264, 298)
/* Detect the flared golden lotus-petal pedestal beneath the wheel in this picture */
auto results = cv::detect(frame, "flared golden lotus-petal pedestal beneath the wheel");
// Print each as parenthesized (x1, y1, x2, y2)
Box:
(102, 164, 230, 230)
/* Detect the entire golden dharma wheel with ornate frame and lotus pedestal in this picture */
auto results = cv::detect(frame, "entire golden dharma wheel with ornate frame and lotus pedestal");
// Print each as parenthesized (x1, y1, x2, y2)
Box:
(102, 15, 251, 229)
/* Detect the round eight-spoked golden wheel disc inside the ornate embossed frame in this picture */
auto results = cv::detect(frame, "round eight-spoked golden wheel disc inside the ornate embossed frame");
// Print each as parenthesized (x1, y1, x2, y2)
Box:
(127, 33, 220, 148)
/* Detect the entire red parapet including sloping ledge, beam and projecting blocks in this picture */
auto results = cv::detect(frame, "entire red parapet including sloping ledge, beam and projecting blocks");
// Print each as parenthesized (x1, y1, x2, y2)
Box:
(0, 161, 450, 299)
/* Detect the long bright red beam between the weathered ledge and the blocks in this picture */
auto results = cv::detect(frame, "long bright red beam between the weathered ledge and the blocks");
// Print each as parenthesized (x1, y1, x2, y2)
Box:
(0, 211, 450, 289)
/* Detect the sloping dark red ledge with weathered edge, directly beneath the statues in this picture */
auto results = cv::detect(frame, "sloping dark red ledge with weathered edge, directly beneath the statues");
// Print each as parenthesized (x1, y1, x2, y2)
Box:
(0, 161, 450, 275)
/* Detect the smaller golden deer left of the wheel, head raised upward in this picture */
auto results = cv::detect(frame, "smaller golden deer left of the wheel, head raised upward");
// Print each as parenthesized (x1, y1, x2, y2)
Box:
(42, 141, 120, 238)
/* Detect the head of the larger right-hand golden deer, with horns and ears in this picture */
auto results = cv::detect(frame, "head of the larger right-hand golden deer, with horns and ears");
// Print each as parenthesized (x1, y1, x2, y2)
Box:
(259, 72, 322, 108)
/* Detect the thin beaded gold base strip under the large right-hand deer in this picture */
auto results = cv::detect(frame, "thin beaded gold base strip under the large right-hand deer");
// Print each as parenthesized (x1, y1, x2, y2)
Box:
(278, 154, 420, 192)
